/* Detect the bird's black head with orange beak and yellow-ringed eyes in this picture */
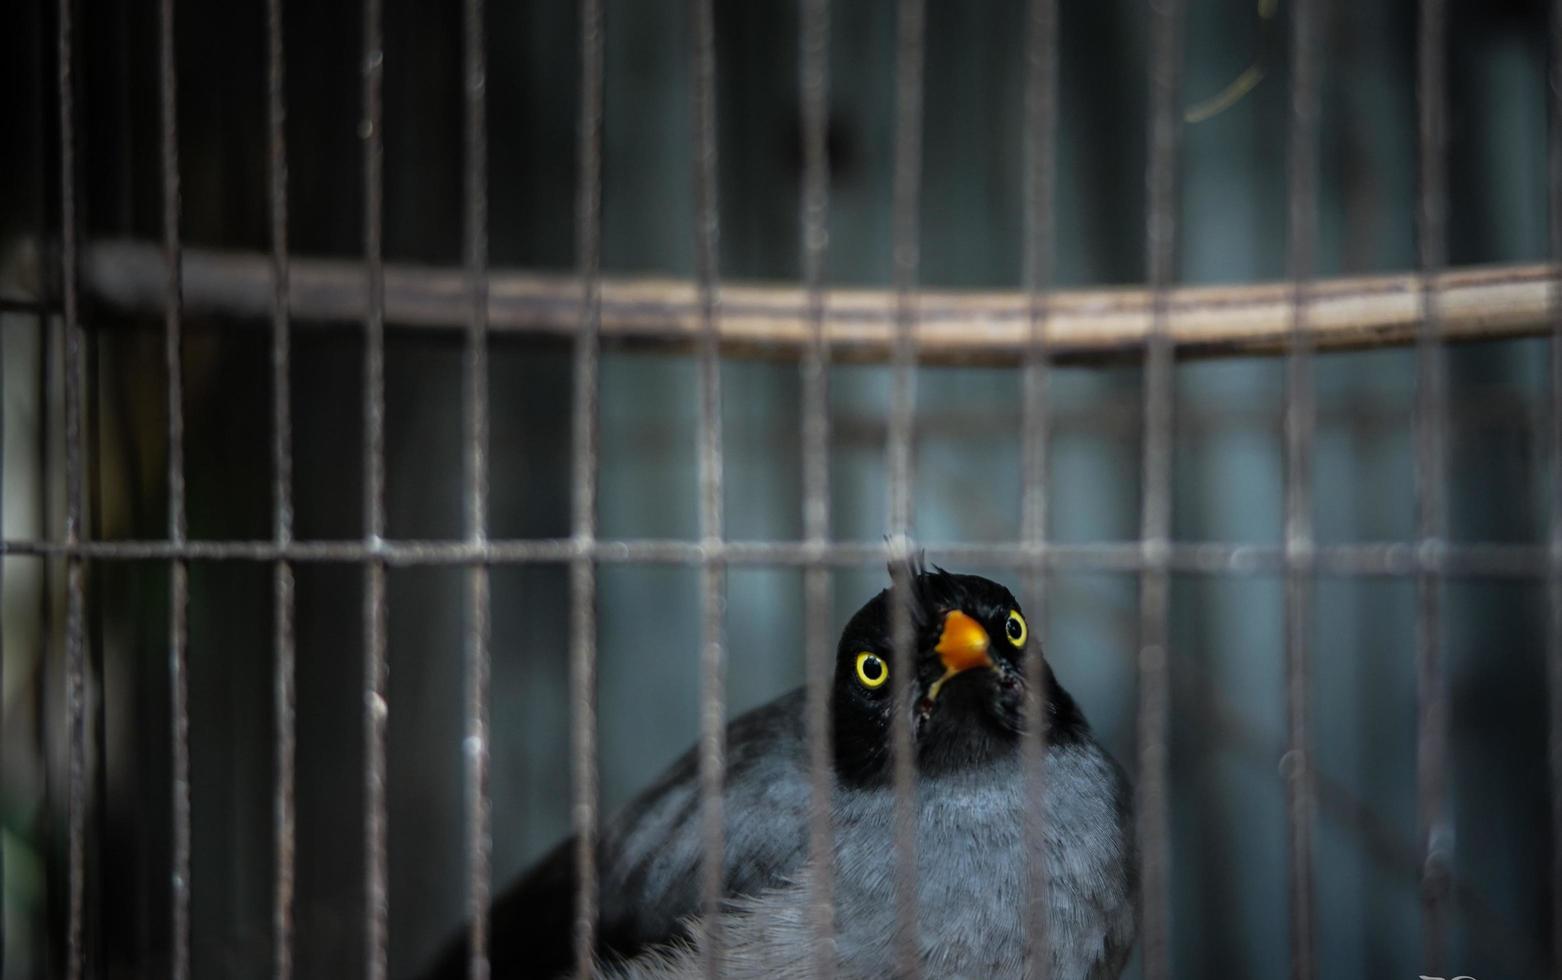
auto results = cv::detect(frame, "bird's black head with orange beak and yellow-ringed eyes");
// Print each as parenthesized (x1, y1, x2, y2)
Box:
(833, 561, 1086, 783)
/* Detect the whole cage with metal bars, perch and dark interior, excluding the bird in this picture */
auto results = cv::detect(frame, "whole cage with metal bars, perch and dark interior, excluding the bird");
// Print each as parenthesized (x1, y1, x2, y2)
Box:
(0, 0, 1562, 980)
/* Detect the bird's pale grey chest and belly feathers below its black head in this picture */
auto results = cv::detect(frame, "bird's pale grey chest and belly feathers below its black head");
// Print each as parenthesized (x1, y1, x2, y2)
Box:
(604, 741, 1136, 980)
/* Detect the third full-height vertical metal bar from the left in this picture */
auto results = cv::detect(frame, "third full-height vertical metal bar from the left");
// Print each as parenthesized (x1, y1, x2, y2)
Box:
(266, 0, 297, 980)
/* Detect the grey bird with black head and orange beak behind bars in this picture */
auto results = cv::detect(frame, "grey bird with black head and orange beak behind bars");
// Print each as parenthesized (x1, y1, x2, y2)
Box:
(436, 558, 1137, 980)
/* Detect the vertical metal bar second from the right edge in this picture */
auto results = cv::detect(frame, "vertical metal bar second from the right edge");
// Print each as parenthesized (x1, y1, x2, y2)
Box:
(1415, 0, 1453, 974)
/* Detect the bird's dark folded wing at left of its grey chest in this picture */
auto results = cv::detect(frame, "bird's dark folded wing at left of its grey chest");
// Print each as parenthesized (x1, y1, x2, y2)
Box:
(430, 691, 809, 980)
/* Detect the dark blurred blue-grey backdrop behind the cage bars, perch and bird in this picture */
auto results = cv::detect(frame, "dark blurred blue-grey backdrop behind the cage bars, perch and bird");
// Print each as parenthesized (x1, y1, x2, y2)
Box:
(0, 0, 1556, 980)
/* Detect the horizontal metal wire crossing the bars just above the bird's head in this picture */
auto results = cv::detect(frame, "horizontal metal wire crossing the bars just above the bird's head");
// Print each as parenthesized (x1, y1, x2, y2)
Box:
(0, 538, 1550, 578)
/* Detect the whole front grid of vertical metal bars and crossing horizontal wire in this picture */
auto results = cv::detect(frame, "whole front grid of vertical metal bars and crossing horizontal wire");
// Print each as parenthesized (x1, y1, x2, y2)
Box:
(12, 0, 1562, 978)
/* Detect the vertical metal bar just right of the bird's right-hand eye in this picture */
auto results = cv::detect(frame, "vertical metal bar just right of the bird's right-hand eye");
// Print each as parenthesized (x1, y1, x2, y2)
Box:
(1020, 0, 1057, 980)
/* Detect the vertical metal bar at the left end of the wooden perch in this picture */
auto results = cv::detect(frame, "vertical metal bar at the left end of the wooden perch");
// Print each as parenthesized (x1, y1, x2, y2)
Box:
(56, 0, 87, 980)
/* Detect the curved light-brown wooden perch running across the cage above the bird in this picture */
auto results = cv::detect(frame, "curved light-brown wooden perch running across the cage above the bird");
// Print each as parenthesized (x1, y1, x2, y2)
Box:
(81, 241, 1553, 364)
